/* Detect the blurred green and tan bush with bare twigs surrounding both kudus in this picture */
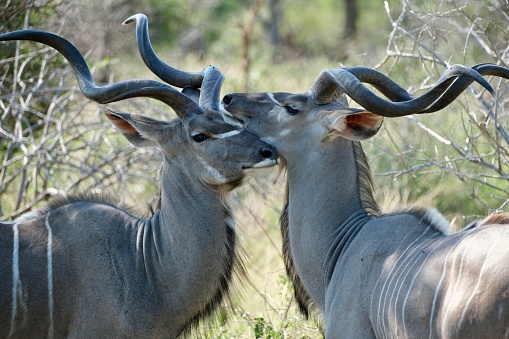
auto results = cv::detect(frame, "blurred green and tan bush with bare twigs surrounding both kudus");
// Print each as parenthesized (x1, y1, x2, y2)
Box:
(0, 0, 509, 338)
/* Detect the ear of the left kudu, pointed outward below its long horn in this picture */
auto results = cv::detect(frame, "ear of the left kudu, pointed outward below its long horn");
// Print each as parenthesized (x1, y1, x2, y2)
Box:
(105, 111, 168, 147)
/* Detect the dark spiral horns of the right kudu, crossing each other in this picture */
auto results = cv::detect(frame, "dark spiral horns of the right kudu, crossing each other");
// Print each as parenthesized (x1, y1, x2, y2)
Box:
(310, 65, 494, 117)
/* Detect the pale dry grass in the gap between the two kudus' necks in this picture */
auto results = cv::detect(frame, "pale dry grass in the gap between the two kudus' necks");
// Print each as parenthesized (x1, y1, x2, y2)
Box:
(196, 174, 323, 338)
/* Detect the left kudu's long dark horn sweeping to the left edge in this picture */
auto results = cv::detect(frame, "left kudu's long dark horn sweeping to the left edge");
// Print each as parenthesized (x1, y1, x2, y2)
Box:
(0, 30, 201, 118)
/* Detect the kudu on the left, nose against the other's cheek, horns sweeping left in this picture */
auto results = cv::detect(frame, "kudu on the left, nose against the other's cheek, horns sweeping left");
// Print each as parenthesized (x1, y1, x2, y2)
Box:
(0, 15, 277, 338)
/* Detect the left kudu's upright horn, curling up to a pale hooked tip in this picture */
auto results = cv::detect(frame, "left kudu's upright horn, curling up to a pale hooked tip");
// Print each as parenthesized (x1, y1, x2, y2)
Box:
(122, 13, 204, 88)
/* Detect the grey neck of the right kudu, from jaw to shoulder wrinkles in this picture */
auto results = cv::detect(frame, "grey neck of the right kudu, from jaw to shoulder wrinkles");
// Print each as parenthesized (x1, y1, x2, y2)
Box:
(286, 138, 376, 311)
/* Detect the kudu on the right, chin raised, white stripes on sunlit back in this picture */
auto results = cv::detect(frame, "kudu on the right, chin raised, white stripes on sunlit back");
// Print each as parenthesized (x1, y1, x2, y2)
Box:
(222, 64, 509, 338)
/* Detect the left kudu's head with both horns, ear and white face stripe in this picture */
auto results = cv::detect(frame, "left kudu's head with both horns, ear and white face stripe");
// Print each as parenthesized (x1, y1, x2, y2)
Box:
(0, 14, 277, 189)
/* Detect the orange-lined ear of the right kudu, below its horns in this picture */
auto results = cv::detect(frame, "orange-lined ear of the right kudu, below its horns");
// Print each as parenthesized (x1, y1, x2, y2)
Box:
(326, 109, 384, 141)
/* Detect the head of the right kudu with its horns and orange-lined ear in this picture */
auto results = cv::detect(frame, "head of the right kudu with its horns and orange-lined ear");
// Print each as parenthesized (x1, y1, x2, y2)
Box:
(221, 64, 509, 157)
